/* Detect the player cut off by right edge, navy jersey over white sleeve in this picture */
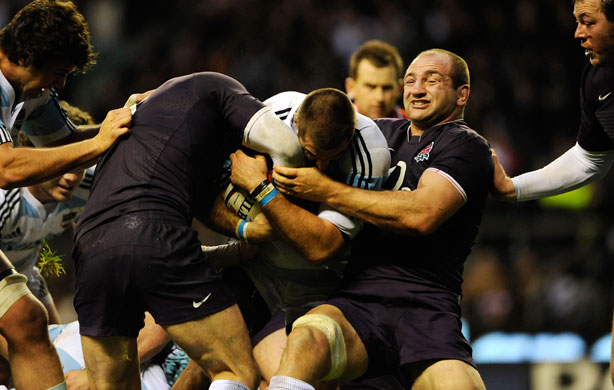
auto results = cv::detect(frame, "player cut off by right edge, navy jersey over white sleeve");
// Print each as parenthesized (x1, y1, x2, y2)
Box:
(493, 0, 614, 383)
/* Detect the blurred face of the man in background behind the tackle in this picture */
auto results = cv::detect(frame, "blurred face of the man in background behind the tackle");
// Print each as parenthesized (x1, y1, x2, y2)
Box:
(345, 59, 401, 118)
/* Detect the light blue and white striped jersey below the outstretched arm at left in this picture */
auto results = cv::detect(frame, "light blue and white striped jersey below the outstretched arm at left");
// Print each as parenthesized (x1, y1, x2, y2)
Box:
(0, 167, 95, 277)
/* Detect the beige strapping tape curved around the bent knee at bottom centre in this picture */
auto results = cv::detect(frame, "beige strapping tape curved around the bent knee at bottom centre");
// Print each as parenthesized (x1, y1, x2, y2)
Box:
(292, 314, 347, 381)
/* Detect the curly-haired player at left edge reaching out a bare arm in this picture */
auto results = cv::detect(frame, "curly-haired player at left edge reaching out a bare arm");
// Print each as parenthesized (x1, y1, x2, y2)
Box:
(0, 0, 131, 390)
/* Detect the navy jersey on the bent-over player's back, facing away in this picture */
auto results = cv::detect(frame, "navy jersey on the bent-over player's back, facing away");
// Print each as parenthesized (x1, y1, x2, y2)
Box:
(77, 72, 264, 236)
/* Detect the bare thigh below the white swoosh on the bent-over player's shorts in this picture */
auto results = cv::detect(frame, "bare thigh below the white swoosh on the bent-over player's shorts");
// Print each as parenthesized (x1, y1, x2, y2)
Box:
(164, 304, 255, 377)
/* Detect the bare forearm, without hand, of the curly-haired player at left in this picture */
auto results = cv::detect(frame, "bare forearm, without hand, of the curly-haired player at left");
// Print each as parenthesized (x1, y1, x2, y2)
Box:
(0, 139, 103, 189)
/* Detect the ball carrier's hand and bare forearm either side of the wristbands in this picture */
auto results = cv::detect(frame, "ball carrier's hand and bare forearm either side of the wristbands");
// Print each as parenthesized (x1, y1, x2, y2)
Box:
(230, 150, 344, 265)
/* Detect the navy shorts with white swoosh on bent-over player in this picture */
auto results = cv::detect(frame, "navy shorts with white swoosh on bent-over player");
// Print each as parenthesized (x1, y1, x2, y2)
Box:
(73, 213, 235, 337)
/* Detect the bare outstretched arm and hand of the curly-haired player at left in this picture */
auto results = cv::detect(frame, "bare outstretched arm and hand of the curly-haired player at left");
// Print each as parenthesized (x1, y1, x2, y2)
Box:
(0, 108, 132, 189)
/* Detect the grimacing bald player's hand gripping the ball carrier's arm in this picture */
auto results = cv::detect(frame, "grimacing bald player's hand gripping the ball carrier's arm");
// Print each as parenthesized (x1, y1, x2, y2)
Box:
(273, 165, 334, 202)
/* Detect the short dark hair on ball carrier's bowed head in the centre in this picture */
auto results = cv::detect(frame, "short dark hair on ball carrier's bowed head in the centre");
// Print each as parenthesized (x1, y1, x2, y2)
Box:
(297, 88, 356, 150)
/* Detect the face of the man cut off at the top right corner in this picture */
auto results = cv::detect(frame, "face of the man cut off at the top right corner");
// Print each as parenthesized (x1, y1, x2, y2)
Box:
(574, 0, 614, 66)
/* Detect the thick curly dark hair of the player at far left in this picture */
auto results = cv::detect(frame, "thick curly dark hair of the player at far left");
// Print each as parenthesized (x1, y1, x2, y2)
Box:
(0, 0, 97, 73)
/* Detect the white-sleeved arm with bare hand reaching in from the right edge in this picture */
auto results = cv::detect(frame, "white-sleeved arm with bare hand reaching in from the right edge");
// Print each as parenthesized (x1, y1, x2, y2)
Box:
(492, 143, 614, 201)
